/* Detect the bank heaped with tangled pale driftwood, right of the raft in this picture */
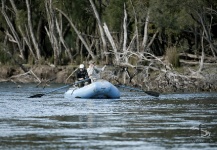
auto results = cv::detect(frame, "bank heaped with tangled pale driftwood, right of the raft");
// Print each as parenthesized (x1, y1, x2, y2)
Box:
(102, 47, 216, 92)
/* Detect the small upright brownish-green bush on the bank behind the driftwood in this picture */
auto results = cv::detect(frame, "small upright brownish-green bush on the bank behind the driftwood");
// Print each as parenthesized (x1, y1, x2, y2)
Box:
(166, 47, 180, 68)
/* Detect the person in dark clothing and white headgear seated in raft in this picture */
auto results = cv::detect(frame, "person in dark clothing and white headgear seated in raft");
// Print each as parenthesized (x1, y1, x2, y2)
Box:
(77, 64, 90, 87)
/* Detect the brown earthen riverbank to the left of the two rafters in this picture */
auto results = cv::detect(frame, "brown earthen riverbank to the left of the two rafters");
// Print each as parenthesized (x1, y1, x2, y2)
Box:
(0, 65, 76, 83)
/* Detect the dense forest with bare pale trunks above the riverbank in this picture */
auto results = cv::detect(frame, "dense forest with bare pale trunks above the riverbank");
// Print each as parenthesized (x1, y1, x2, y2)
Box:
(0, 0, 217, 92)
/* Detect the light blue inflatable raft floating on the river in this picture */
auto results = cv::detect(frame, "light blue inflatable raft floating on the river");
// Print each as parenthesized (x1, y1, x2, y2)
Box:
(64, 80, 120, 99)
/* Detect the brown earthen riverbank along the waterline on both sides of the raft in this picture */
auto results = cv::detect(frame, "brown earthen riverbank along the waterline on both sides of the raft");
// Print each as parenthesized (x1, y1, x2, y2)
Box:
(0, 65, 217, 93)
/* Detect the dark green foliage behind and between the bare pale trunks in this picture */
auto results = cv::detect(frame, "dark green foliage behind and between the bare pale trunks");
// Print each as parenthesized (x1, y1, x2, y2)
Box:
(0, 0, 217, 66)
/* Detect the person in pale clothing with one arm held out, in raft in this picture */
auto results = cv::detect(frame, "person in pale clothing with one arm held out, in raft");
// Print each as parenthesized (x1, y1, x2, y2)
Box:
(87, 60, 106, 82)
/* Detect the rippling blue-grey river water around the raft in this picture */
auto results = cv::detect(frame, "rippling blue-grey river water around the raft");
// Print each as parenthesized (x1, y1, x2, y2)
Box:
(0, 83, 217, 150)
